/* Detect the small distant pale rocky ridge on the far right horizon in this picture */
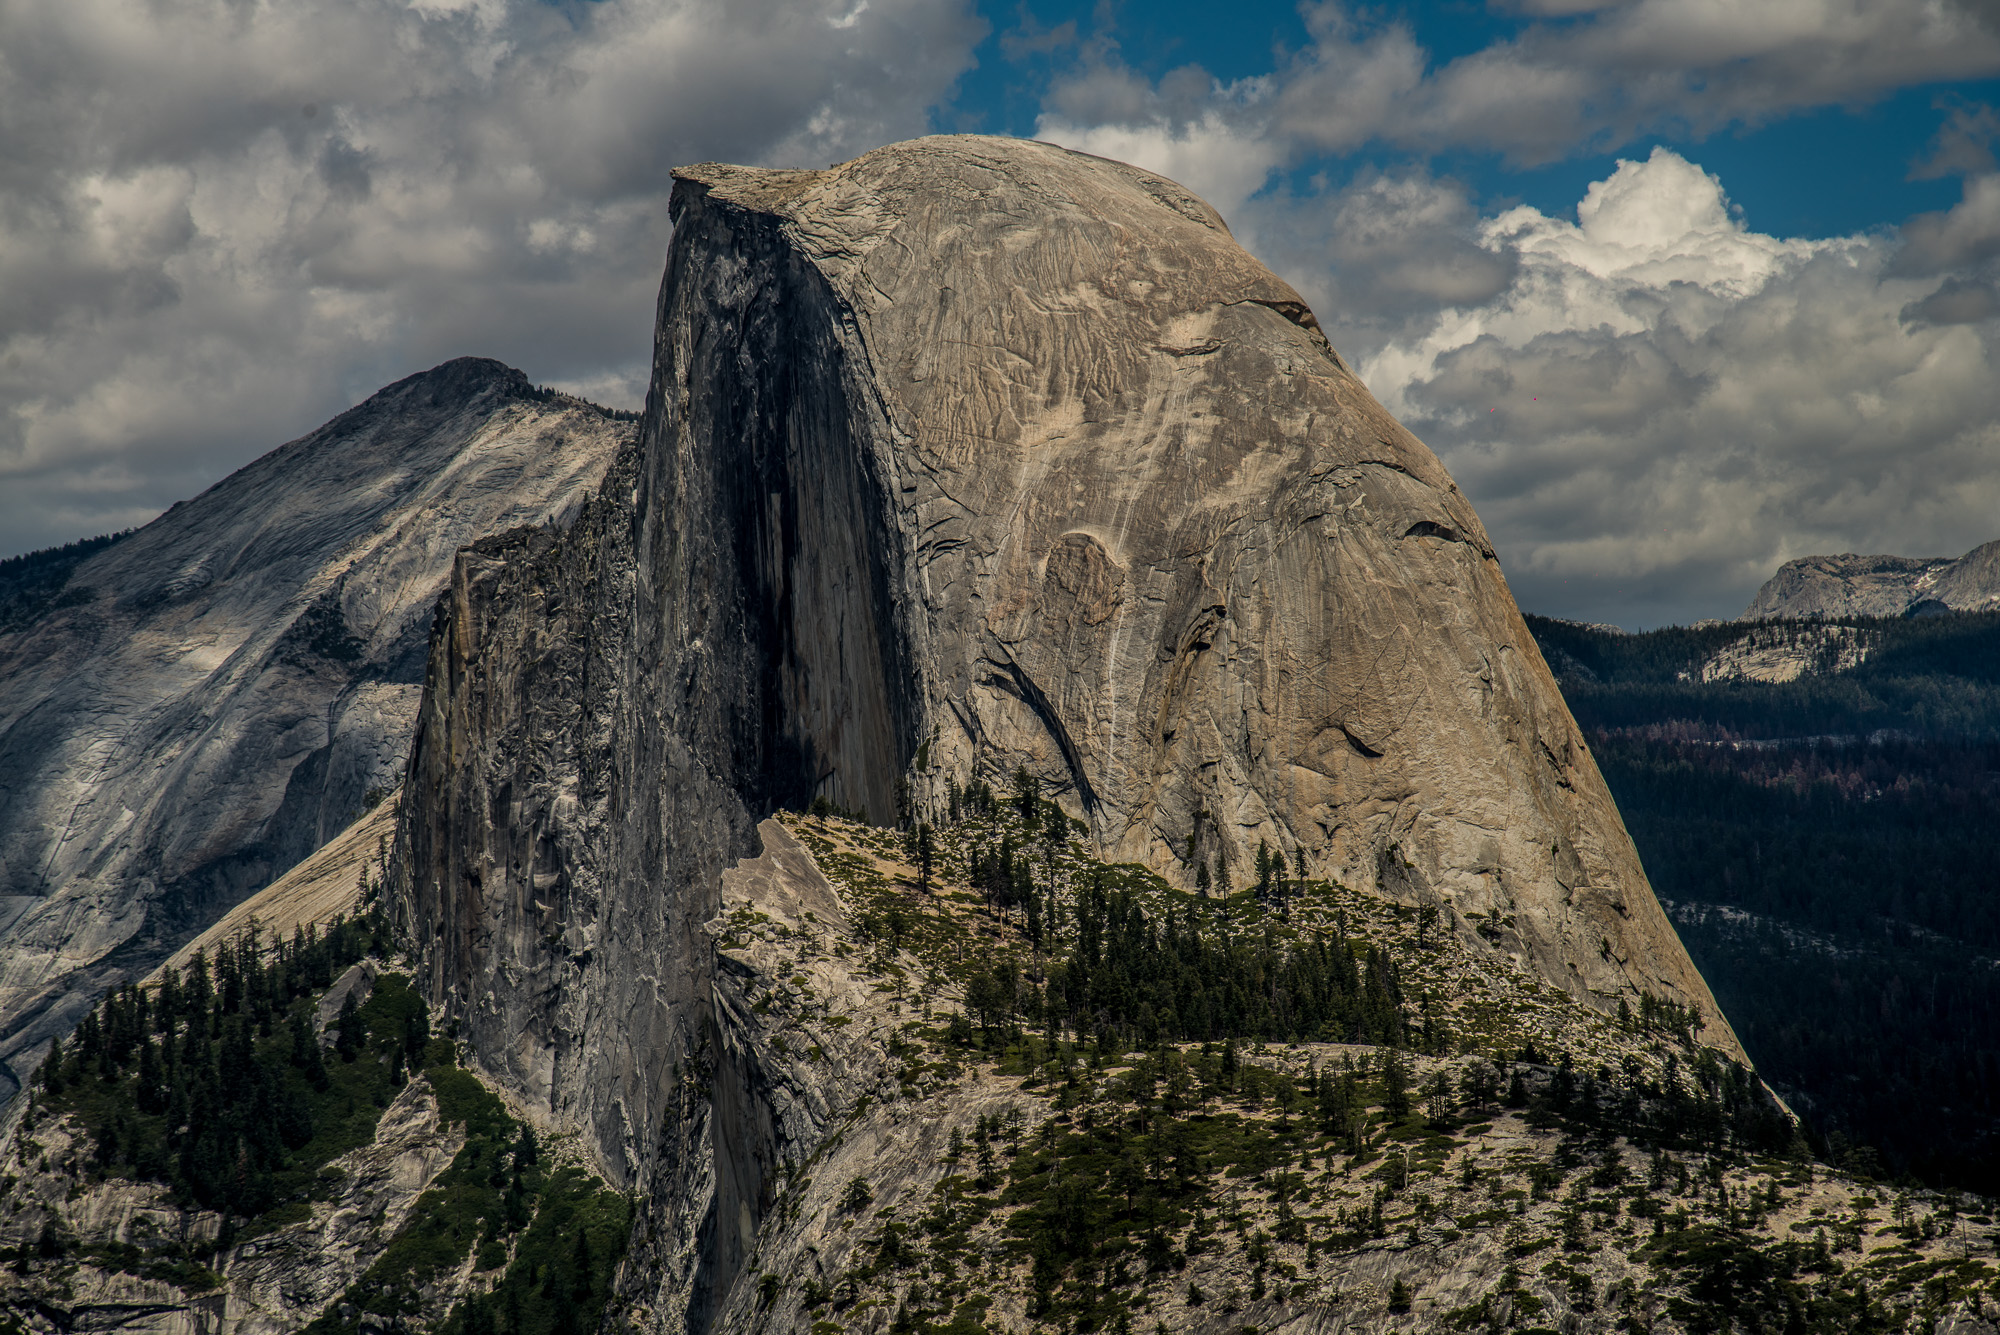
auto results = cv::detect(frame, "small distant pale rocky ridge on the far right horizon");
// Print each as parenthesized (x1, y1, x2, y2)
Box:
(1742, 542, 2000, 622)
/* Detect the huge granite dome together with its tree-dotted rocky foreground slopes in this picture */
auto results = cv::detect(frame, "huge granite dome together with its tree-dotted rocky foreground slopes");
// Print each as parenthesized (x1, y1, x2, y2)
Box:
(15, 136, 1996, 1335)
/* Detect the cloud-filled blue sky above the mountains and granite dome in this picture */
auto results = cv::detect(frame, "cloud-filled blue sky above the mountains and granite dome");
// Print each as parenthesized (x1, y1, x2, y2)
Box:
(0, 0, 2000, 626)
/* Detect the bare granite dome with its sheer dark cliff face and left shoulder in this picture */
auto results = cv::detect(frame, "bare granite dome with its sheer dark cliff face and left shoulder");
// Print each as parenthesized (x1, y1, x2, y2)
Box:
(394, 138, 1738, 1329)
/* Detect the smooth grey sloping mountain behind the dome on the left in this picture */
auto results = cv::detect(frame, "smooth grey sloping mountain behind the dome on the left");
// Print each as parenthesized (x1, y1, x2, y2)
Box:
(0, 358, 632, 1097)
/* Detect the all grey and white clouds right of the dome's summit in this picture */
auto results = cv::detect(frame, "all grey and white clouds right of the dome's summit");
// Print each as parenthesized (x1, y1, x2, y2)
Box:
(1040, 0, 2000, 626)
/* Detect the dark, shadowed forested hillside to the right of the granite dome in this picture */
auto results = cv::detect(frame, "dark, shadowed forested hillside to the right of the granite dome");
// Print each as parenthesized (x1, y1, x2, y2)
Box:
(1528, 614, 2000, 1193)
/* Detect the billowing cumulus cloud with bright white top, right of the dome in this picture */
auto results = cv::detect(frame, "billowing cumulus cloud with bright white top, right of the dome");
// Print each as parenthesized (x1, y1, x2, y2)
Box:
(1360, 150, 2000, 620)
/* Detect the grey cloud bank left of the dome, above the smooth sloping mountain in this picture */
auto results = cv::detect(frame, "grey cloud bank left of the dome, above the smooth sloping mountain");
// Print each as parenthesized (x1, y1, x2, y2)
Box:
(0, 0, 986, 550)
